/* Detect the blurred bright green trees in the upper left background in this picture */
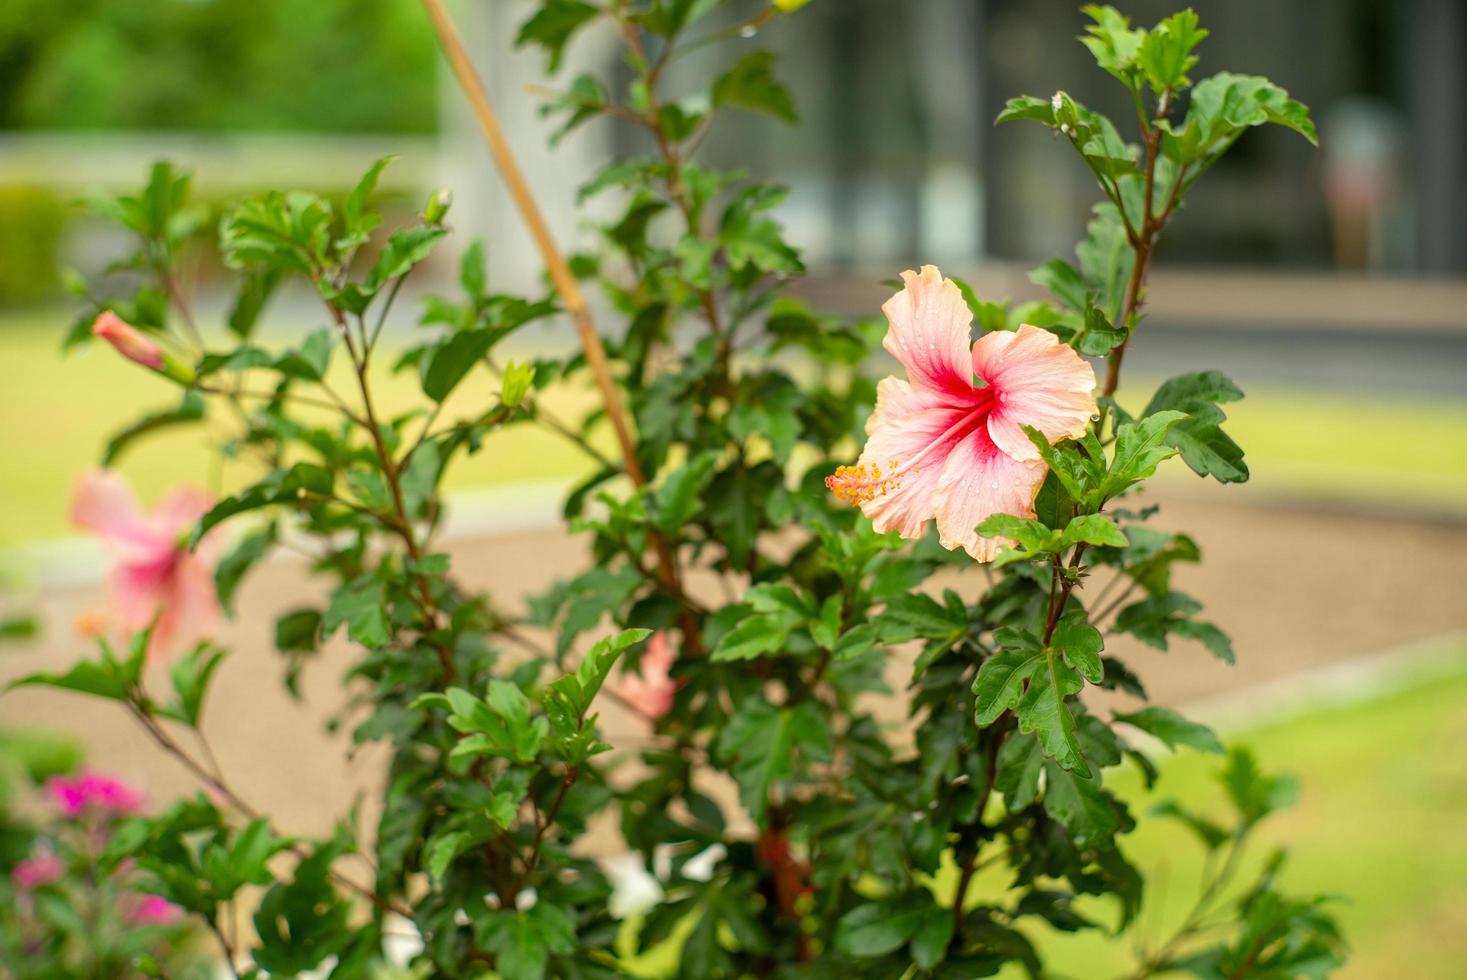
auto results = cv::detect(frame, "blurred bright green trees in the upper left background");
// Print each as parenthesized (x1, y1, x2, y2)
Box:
(0, 0, 436, 132)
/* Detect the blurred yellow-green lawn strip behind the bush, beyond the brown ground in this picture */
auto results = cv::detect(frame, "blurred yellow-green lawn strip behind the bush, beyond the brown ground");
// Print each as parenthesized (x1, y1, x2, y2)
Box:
(0, 310, 1467, 547)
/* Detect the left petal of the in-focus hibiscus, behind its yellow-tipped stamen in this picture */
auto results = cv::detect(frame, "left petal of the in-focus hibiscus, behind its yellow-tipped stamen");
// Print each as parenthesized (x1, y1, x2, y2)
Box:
(855, 377, 968, 538)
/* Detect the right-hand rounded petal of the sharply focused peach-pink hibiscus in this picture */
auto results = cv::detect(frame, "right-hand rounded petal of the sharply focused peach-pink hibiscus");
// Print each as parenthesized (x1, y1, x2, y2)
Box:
(973, 323, 1096, 459)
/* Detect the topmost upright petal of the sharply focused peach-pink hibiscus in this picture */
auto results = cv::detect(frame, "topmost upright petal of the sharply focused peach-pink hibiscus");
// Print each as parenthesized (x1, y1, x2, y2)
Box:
(882, 266, 973, 396)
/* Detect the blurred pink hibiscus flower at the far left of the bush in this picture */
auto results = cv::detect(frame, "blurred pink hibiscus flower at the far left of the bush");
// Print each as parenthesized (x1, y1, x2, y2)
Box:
(72, 469, 220, 656)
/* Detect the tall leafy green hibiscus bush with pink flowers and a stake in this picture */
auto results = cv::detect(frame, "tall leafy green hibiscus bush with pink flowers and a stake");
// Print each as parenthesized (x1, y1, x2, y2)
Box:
(8, 0, 1342, 980)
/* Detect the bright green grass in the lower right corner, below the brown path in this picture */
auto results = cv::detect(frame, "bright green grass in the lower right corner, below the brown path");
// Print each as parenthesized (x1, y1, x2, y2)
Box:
(623, 648, 1467, 980)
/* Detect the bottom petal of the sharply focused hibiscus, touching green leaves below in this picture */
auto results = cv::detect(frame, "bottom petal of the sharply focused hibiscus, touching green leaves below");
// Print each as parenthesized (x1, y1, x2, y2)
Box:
(933, 430, 1049, 562)
